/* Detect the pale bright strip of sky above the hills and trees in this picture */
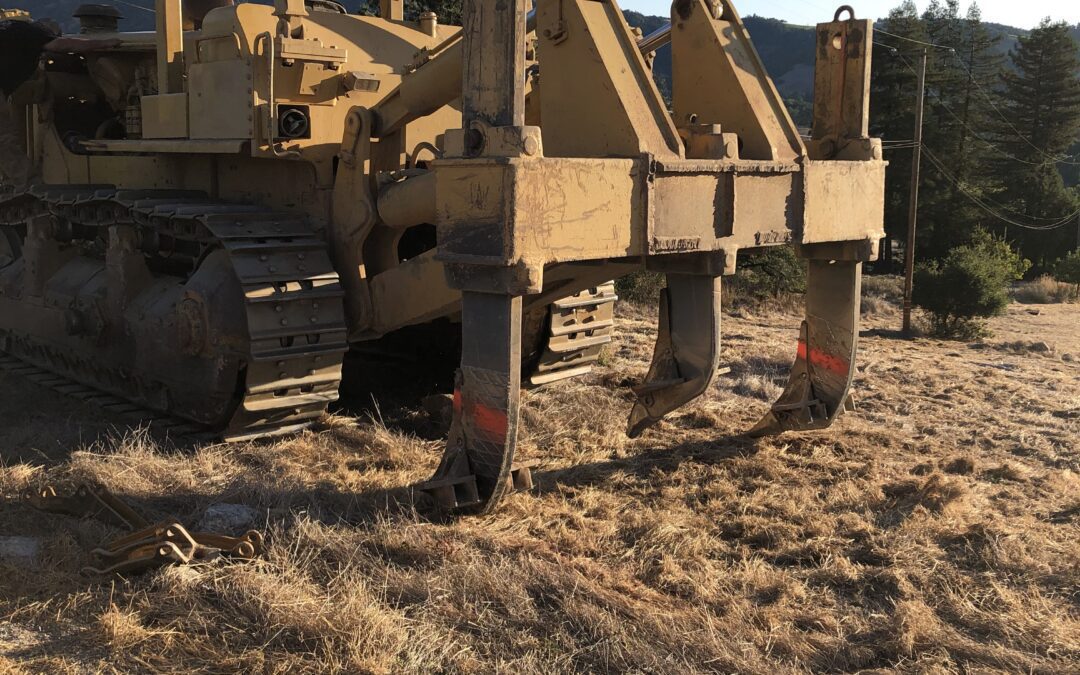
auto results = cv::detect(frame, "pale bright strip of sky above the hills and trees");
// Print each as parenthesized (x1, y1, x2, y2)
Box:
(619, 0, 1080, 28)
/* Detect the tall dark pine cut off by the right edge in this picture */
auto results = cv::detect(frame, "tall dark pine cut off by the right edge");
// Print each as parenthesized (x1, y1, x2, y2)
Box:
(995, 18, 1080, 265)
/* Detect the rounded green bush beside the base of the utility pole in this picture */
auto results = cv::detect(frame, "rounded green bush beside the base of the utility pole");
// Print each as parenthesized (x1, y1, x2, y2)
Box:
(912, 232, 1031, 339)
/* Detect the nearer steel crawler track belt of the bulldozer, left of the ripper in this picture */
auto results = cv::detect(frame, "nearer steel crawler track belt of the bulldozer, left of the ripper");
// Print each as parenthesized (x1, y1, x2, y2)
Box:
(0, 186, 348, 442)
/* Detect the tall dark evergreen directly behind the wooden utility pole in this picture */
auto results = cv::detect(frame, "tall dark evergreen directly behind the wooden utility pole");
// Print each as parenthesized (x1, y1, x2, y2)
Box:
(872, 0, 1001, 265)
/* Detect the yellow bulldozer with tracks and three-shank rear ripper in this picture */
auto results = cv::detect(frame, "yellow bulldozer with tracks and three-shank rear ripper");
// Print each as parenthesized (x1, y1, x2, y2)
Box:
(0, 0, 886, 511)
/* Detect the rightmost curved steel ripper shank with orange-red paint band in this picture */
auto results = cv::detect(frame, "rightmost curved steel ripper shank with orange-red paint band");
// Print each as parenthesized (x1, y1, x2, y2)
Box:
(750, 259, 862, 436)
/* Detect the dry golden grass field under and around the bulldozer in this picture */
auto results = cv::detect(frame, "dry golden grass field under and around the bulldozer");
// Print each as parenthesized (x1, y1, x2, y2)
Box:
(0, 280, 1080, 673)
